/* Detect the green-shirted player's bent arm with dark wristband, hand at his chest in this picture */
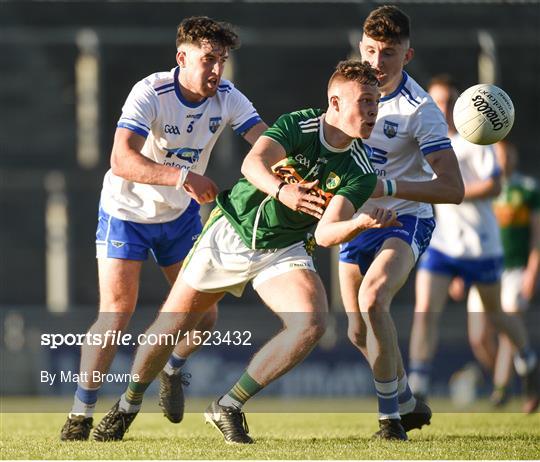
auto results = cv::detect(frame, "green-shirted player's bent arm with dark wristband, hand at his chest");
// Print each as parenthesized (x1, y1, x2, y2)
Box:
(242, 136, 325, 218)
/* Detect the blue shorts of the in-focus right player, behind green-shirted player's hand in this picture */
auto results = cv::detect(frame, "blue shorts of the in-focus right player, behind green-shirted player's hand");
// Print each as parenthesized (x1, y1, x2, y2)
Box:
(339, 215, 435, 274)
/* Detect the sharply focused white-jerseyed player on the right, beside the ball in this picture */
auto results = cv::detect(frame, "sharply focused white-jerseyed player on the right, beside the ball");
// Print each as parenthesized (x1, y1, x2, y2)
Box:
(339, 6, 463, 440)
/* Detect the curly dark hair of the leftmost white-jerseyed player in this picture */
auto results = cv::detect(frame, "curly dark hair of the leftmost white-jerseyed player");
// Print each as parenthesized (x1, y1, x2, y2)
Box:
(176, 16, 240, 49)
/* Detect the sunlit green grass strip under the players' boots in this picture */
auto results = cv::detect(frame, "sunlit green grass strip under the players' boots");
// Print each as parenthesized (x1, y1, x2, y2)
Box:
(0, 400, 540, 459)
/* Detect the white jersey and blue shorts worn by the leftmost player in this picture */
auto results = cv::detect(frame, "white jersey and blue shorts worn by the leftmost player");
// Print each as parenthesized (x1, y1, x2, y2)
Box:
(96, 67, 261, 266)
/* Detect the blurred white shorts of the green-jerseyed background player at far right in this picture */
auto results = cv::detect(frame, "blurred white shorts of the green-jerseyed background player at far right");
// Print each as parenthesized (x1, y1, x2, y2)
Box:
(467, 268, 529, 313)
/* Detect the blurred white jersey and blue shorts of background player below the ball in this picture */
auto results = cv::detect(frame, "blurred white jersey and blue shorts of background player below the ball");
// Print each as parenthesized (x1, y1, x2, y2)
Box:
(419, 134, 503, 285)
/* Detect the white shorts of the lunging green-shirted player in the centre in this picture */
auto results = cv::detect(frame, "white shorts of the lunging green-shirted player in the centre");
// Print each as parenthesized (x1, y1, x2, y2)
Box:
(182, 217, 316, 297)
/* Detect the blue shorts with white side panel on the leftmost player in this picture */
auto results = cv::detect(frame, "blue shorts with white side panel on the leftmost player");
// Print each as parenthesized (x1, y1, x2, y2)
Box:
(96, 200, 202, 266)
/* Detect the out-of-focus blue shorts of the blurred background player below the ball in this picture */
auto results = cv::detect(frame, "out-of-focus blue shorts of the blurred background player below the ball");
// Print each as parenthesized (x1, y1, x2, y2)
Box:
(418, 248, 504, 286)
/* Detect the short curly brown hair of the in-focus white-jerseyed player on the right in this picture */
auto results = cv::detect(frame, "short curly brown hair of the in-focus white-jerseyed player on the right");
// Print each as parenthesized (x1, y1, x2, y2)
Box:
(364, 5, 411, 43)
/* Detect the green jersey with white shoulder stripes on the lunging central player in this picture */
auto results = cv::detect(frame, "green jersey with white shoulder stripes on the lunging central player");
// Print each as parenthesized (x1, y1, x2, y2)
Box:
(216, 109, 377, 249)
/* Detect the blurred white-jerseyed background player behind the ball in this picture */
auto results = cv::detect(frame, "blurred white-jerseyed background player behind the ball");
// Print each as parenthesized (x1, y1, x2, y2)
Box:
(410, 76, 538, 414)
